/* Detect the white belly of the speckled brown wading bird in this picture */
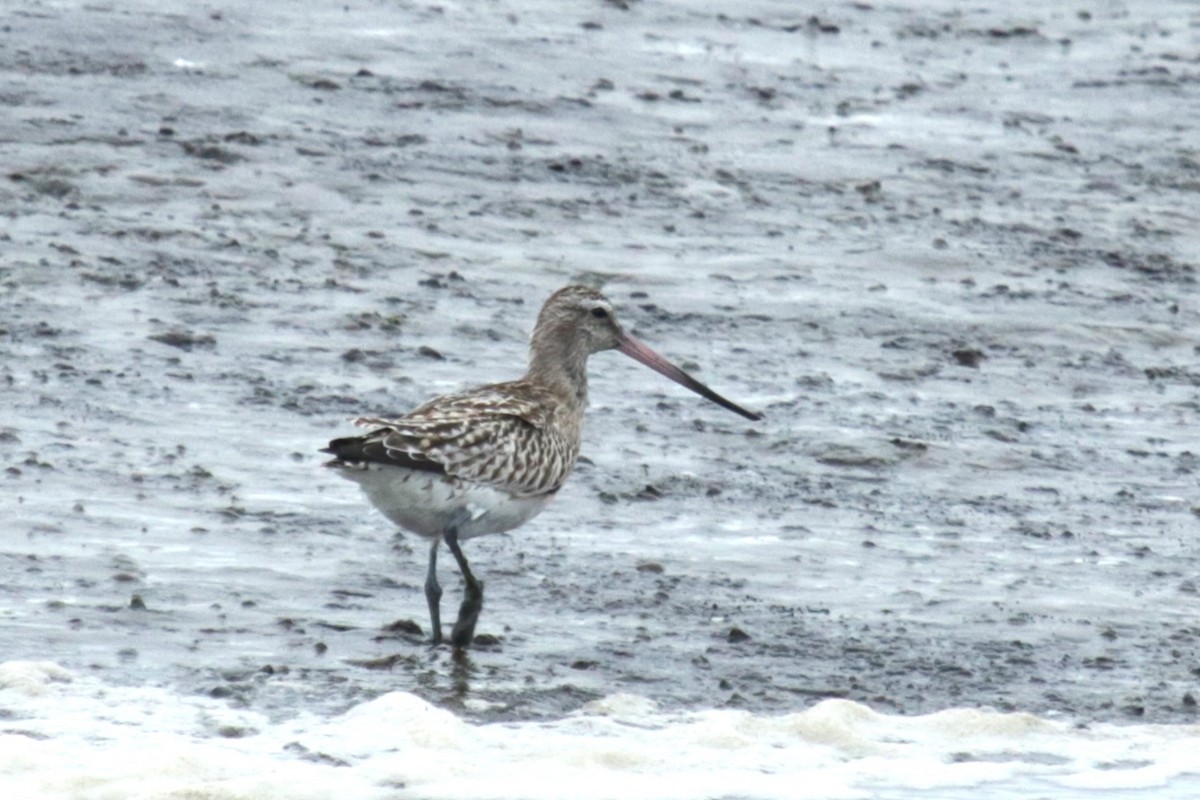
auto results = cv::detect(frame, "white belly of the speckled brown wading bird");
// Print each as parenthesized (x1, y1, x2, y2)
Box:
(328, 463, 553, 539)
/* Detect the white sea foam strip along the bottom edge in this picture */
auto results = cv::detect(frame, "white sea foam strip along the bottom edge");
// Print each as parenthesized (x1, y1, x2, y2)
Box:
(0, 662, 1200, 800)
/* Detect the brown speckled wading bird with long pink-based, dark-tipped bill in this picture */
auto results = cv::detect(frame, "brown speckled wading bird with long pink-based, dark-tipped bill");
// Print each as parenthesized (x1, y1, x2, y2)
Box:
(324, 285, 762, 648)
